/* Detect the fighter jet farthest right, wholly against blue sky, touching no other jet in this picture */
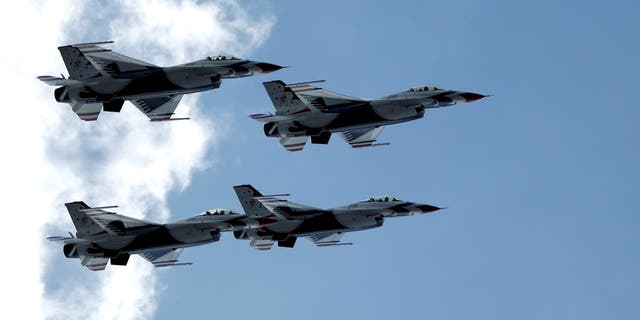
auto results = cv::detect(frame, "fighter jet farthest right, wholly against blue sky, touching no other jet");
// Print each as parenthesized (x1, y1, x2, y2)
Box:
(251, 80, 485, 151)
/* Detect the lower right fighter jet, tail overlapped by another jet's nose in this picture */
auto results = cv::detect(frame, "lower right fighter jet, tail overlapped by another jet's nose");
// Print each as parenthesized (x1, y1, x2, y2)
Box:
(234, 185, 441, 250)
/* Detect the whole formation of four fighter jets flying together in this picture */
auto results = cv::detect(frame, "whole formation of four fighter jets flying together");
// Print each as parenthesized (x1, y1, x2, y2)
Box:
(38, 41, 485, 270)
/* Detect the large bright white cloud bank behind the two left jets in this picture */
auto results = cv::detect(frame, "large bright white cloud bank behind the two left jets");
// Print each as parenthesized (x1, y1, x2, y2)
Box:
(0, 1, 273, 319)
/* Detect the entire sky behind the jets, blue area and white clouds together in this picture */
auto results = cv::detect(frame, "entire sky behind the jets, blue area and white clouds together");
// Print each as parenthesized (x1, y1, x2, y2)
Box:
(18, 0, 640, 319)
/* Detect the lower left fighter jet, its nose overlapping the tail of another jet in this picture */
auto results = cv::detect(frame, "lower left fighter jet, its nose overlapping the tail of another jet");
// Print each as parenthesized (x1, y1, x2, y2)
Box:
(47, 201, 277, 271)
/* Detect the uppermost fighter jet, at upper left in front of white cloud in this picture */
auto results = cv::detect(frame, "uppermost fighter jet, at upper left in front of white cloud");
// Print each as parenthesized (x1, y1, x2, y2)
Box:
(38, 41, 283, 121)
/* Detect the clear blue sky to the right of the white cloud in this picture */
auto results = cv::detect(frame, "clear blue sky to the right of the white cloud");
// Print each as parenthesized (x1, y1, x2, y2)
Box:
(156, 1, 640, 319)
